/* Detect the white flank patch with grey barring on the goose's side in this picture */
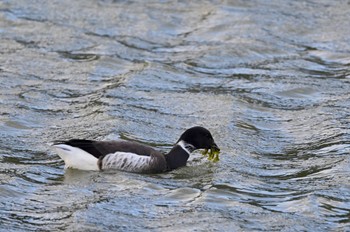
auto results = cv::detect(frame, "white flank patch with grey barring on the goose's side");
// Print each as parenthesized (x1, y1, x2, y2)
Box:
(102, 152, 153, 172)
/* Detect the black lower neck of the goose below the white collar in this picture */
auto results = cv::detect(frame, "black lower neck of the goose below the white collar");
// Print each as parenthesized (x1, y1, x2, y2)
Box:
(165, 145, 190, 171)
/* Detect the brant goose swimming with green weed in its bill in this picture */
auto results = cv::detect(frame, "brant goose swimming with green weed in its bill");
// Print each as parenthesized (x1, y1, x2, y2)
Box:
(53, 126, 220, 173)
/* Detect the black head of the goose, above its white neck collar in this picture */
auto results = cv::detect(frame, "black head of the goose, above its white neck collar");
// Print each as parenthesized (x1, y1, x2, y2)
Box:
(179, 126, 219, 150)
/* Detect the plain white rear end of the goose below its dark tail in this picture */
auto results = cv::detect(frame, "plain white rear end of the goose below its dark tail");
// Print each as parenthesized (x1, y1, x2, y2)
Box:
(53, 144, 99, 170)
